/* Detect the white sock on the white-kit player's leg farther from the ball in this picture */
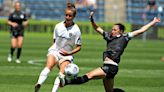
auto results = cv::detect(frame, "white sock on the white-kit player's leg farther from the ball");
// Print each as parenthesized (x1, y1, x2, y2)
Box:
(38, 67, 50, 85)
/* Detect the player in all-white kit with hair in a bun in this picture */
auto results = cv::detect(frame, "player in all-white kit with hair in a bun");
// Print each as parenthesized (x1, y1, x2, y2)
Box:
(35, 3, 81, 92)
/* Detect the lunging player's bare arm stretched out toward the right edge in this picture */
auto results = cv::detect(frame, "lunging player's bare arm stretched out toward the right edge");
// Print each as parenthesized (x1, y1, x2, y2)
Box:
(131, 17, 160, 36)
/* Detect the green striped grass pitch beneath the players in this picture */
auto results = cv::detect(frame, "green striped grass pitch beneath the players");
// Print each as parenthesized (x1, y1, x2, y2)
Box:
(0, 32, 164, 92)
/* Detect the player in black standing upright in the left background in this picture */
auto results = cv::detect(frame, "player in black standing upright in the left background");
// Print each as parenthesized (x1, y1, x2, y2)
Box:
(7, 2, 28, 63)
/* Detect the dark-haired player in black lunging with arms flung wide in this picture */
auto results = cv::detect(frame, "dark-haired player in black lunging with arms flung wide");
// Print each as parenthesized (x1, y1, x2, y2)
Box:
(59, 12, 160, 92)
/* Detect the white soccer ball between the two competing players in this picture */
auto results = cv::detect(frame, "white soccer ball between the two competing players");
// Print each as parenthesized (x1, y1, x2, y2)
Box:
(64, 63, 79, 78)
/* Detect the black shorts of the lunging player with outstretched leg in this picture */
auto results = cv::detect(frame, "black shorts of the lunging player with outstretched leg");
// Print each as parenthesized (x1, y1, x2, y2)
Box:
(101, 64, 118, 79)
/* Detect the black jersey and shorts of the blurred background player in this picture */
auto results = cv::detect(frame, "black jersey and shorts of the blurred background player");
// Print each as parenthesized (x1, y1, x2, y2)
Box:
(8, 11, 27, 31)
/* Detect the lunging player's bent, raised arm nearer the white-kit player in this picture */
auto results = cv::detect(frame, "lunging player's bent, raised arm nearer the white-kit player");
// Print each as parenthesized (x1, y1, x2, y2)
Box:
(90, 12, 104, 35)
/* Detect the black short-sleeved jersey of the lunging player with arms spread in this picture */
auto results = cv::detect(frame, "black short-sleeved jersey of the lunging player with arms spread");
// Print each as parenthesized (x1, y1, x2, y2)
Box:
(103, 32, 131, 63)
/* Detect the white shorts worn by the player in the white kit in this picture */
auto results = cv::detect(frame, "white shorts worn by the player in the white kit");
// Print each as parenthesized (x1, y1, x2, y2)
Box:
(47, 50, 73, 65)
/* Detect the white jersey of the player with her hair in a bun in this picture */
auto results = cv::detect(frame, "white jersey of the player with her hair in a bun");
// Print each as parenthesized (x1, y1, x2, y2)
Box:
(49, 22, 81, 52)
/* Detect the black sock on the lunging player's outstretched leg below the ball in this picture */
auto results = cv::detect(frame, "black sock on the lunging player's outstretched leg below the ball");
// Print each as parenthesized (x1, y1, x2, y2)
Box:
(66, 75, 89, 85)
